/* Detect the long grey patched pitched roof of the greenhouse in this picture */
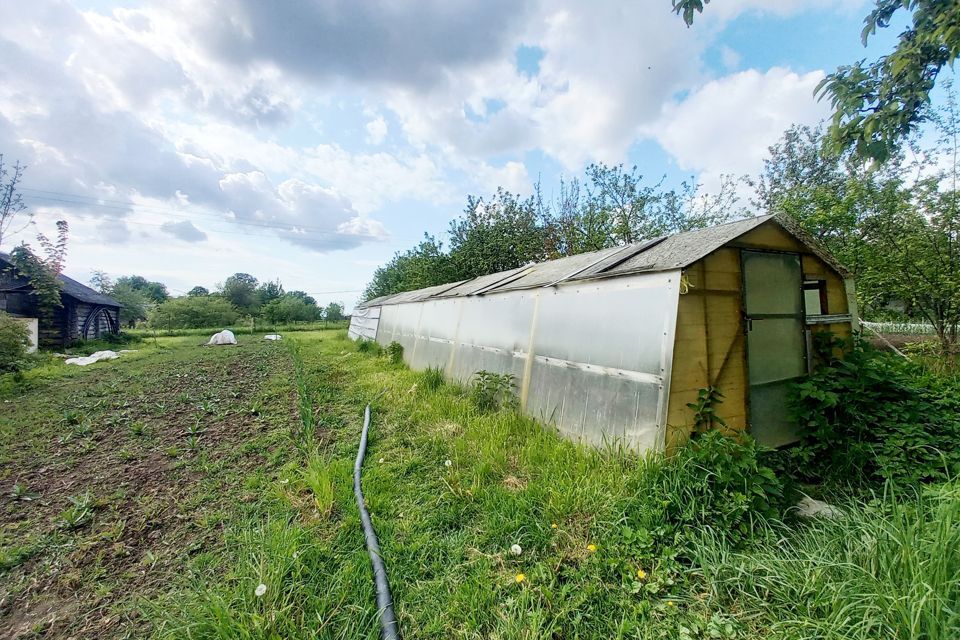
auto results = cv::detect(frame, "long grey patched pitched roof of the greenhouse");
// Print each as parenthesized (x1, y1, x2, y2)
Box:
(358, 214, 849, 307)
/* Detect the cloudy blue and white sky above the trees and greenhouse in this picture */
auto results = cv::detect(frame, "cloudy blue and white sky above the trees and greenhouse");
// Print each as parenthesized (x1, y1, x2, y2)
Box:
(0, 0, 916, 308)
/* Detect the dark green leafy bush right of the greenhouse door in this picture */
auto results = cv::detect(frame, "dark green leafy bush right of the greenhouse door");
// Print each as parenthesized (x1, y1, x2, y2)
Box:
(791, 343, 960, 484)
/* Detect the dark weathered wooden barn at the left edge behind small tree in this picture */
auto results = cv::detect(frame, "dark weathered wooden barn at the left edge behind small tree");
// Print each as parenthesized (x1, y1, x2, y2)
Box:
(0, 253, 120, 347)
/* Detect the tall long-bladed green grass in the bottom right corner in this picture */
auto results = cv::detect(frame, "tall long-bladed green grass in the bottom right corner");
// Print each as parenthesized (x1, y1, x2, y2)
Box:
(695, 481, 960, 640)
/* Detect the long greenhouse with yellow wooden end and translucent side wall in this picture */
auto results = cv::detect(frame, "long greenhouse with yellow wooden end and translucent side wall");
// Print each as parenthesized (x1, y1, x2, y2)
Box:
(350, 215, 857, 450)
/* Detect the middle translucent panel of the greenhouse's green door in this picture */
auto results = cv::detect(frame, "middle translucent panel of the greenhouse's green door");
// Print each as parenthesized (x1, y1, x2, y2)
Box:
(747, 318, 807, 385)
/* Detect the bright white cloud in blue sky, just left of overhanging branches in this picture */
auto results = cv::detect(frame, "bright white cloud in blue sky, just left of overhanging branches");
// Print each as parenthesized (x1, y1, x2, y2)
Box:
(646, 67, 827, 185)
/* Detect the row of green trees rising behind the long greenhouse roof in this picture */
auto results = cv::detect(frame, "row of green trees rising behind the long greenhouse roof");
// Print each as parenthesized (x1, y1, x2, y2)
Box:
(364, 164, 743, 300)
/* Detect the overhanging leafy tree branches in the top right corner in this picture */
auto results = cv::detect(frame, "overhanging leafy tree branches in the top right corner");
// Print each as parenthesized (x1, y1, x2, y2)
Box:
(672, 0, 960, 162)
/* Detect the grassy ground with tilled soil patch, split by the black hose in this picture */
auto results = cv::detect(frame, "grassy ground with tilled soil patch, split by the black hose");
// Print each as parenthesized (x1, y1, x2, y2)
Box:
(0, 330, 960, 639)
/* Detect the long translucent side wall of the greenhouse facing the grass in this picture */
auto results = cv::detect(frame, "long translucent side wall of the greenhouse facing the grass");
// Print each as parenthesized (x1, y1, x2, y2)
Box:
(366, 271, 680, 451)
